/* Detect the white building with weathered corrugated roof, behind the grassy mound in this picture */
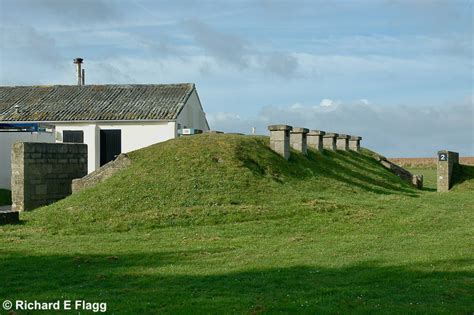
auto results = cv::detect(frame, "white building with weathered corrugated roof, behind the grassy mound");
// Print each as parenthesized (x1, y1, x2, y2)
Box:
(0, 83, 209, 183)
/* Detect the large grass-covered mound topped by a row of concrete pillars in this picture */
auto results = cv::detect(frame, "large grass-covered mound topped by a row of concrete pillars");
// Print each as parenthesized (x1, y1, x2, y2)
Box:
(24, 135, 416, 232)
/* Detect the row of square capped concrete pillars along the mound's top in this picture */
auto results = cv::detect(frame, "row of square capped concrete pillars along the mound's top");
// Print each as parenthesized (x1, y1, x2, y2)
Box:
(268, 125, 362, 160)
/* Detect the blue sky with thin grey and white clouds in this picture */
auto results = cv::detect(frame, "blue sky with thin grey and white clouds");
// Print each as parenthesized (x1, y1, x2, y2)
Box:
(0, 0, 474, 157)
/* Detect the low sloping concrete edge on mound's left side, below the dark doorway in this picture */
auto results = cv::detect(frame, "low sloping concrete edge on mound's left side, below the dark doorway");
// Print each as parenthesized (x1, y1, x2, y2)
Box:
(72, 153, 132, 194)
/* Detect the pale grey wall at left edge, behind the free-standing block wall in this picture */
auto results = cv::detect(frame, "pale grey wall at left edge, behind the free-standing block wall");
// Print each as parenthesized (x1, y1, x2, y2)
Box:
(0, 131, 55, 190)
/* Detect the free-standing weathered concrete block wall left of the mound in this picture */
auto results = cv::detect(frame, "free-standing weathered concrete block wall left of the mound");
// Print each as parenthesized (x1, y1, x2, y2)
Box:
(11, 142, 87, 211)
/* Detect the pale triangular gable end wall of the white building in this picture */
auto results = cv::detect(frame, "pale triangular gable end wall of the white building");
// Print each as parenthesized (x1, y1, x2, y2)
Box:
(176, 90, 209, 131)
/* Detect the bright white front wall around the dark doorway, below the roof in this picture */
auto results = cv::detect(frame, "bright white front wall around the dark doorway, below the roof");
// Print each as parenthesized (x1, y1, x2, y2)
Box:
(55, 121, 177, 173)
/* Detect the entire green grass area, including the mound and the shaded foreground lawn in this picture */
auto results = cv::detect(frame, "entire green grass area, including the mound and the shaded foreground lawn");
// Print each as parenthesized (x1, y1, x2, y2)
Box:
(0, 135, 474, 314)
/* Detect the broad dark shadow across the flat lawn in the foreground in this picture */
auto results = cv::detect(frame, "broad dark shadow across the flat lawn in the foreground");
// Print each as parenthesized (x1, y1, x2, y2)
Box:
(0, 250, 474, 314)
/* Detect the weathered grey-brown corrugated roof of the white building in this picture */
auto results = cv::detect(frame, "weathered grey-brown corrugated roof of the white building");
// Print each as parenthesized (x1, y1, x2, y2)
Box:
(0, 83, 194, 121)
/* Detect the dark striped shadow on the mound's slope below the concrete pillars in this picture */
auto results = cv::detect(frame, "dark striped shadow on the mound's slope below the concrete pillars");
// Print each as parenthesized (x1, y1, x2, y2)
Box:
(237, 142, 418, 197)
